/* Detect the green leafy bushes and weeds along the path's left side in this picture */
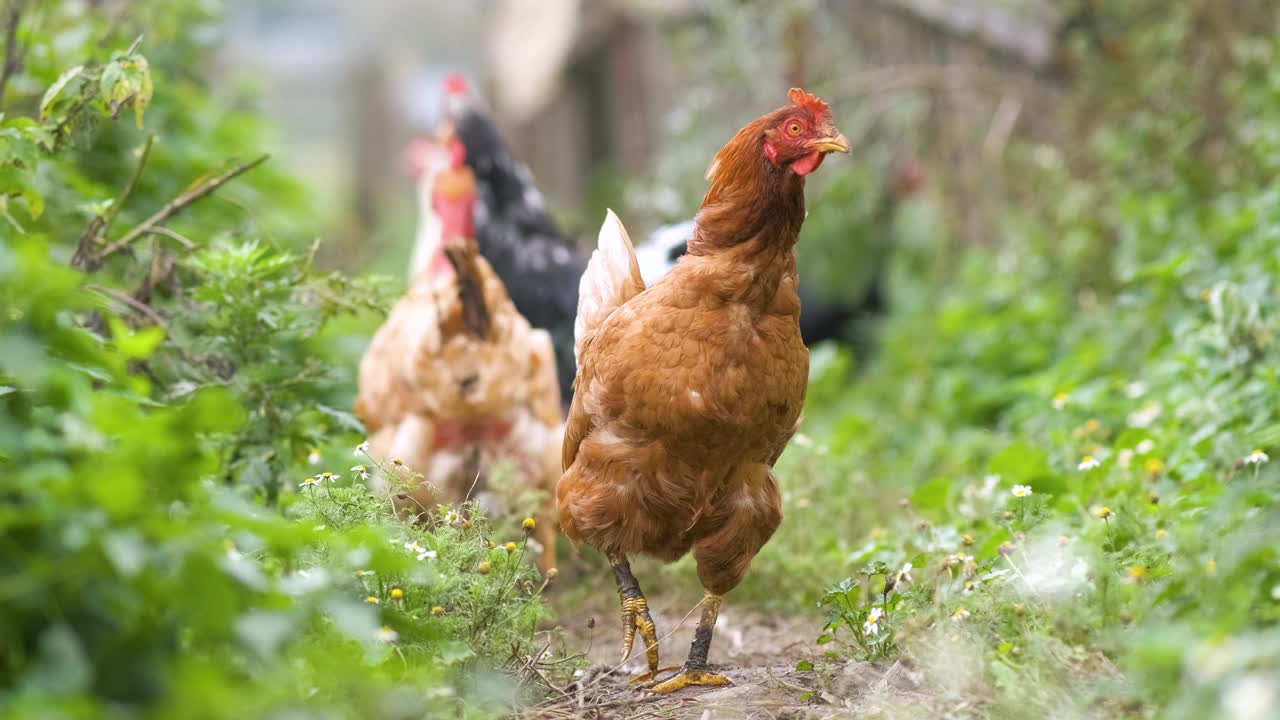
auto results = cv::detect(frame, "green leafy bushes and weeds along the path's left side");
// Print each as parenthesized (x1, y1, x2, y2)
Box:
(0, 3, 554, 717)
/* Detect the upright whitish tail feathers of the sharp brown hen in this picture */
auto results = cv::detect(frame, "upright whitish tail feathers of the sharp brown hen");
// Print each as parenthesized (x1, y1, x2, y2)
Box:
(573, 210, 644, 369)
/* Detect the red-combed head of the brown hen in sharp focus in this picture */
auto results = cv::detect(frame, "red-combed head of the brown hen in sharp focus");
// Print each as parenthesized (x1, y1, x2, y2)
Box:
(763, 87, 849, 176)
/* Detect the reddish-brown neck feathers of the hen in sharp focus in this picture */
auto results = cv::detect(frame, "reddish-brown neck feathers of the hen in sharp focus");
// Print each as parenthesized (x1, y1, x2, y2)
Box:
(689, 109, 805, 307)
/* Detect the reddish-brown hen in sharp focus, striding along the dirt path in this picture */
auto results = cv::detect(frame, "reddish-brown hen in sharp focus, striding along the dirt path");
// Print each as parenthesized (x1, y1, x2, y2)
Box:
(556, 88, 849, 692)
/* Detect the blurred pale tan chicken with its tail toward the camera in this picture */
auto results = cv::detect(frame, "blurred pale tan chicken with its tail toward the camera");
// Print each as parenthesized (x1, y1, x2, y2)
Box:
(356, 131, 563, 571)
